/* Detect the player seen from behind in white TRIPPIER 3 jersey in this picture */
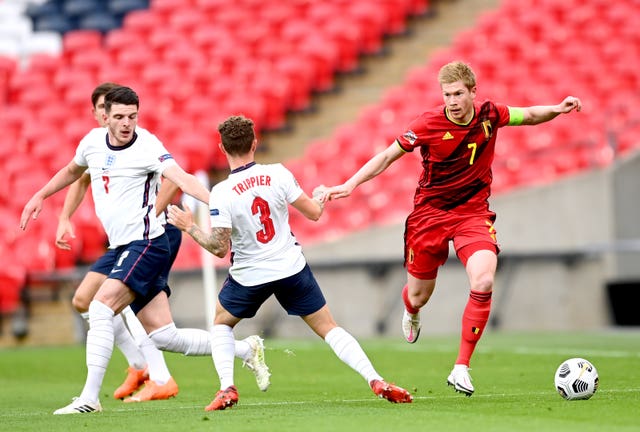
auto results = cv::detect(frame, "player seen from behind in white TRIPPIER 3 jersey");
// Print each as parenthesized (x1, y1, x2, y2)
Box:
(168, 116, 412, 411)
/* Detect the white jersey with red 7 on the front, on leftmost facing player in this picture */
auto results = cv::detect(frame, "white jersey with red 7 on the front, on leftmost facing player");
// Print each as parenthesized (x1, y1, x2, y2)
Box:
(74, 127, 176, 248)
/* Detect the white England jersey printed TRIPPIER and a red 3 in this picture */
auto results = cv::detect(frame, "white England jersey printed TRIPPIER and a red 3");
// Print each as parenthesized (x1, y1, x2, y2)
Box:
(209, 163, 306, 286)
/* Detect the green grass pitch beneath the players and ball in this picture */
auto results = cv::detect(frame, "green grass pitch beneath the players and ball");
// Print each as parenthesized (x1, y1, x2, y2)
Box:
(0, 330, 640, 432)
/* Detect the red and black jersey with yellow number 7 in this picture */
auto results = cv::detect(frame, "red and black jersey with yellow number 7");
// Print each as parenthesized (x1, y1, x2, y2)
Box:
(397, 101, 509, 213)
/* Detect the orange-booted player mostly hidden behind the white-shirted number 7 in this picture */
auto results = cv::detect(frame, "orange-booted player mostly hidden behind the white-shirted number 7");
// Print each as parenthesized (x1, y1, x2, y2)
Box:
(55, 82, 270, 402)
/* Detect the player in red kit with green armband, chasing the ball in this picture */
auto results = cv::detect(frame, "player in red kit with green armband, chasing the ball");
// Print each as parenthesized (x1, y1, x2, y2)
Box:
(322, 61, 581, 396)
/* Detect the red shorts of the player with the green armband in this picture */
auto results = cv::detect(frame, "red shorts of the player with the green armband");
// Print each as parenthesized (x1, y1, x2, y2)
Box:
(404, 206, 500, 280)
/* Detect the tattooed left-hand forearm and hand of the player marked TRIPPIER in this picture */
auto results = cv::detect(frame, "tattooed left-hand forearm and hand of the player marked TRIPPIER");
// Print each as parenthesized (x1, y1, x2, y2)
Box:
(167, 205, 231, 258)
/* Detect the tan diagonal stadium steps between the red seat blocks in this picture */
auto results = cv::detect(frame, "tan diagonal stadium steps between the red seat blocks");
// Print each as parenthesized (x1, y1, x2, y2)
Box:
(256, 0, 501, 163)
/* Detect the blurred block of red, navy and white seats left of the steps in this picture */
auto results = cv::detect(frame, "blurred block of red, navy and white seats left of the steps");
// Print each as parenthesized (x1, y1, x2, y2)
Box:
(0, 0, 426, 280)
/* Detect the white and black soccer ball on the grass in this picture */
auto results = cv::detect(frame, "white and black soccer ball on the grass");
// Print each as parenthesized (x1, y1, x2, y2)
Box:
(554, 358, 598, 400)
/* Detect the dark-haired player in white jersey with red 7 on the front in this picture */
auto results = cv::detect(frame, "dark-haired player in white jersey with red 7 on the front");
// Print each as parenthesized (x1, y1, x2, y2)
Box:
(20, 87, 268, 414)
